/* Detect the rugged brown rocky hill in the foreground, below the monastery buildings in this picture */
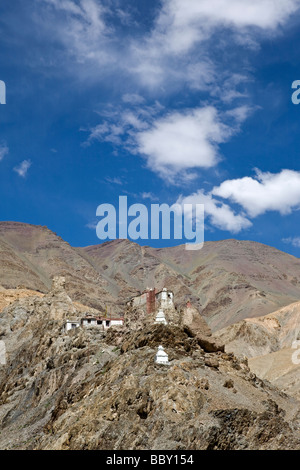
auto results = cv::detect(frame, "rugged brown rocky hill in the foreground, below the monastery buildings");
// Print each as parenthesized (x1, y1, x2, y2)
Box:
(0, 298, 300, 450)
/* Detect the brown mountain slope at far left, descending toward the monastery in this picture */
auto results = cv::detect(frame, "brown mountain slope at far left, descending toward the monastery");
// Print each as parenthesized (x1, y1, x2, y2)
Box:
(0, 222, 114, 310)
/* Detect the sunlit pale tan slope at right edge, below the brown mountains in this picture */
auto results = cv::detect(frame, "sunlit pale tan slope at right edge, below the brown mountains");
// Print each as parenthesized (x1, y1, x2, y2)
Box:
(215, 302, 300, 399)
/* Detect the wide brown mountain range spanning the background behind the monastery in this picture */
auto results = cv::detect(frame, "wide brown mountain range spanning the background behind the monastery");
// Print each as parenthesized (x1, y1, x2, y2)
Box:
(0, 222, 300, 331)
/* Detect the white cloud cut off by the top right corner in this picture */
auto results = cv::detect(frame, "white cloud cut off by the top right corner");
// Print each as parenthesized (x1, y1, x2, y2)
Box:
(151, 0, 300, 54)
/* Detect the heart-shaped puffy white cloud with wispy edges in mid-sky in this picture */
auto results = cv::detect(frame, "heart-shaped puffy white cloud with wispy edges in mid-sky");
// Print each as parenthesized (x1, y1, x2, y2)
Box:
(86, 103, 252, 183)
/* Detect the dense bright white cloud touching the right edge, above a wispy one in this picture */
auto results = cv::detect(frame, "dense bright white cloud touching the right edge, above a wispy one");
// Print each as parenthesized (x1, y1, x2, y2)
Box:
(212, 170, 300, 217)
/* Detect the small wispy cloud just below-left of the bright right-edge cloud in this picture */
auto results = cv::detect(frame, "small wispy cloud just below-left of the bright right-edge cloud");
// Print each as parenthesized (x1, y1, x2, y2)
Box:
(176, 190, 252, 233)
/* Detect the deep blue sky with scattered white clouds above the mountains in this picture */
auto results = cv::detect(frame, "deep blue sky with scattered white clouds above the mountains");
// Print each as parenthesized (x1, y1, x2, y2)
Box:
(0, 0, 300, 256)
